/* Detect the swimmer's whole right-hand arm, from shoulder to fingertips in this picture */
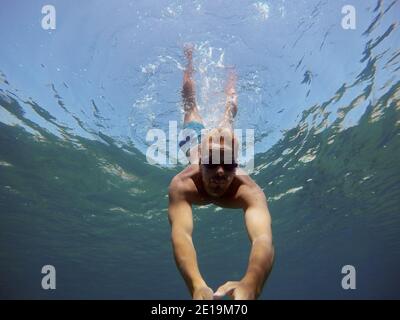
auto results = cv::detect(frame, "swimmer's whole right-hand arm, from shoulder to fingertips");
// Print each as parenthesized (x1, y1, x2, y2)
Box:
(214, 187, 274, 300)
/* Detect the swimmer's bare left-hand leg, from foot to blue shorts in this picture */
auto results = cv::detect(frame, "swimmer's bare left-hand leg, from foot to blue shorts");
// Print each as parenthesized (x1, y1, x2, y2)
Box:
(182, 46, 203, 124)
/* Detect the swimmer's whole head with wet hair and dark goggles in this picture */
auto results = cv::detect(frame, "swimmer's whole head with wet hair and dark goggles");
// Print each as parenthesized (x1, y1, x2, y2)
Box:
(200, 128, 238, 197)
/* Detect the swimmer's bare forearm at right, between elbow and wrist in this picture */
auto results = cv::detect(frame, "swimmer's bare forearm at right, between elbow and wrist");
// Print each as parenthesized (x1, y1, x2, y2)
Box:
(242, 237, 274, 296)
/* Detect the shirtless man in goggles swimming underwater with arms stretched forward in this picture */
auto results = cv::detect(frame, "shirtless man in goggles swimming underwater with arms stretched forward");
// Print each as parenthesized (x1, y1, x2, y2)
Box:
(168, 46, 274, 300)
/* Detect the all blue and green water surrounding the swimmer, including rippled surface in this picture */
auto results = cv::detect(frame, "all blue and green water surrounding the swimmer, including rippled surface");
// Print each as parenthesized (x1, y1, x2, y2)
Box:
(0, 0, 400, 299)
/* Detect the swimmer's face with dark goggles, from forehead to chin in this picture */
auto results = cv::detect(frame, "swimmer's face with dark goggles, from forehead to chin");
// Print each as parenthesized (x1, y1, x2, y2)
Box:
(200, 149, 237, 197)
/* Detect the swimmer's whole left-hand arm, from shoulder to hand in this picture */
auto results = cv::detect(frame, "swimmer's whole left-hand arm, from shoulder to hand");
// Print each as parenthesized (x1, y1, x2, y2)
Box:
(168, 180, 213, 299)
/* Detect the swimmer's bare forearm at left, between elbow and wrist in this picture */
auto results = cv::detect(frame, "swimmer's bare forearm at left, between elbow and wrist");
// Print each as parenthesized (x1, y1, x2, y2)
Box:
(172, 232, 206, 294)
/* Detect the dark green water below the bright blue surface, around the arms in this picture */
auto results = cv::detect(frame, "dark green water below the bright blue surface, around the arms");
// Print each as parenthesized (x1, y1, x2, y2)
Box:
(0, 82, 400, 299)
